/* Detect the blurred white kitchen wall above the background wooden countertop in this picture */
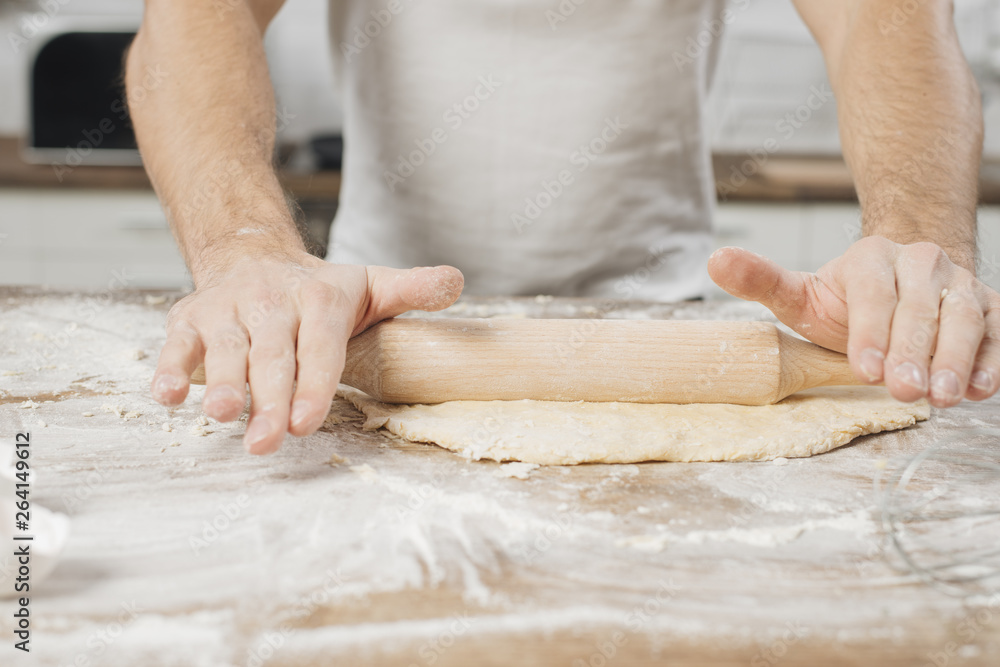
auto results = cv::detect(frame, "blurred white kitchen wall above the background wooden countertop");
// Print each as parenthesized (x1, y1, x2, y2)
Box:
(0, 0, 1000, 157)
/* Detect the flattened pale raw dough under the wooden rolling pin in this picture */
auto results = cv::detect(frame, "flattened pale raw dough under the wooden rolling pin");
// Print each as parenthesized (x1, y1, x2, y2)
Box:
(340, 386, 930, 465)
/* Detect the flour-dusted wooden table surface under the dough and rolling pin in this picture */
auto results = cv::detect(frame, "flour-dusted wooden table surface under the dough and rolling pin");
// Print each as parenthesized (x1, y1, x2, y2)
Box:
(0, 288, 1000, 667)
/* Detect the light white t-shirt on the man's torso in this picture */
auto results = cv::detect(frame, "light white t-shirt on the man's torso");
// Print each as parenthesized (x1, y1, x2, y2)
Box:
(327, 0, 725, 301)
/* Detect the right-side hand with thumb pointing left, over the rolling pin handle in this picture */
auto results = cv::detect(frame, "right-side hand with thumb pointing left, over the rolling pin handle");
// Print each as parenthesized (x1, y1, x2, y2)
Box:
(708, 236, 1000, 407)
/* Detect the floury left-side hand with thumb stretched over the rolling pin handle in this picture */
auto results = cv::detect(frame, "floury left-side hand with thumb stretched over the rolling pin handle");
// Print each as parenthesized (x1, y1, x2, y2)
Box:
(152, 253, 463, 454)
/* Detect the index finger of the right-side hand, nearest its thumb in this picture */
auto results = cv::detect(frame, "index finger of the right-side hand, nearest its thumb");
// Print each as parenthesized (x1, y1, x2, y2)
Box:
(844, 253, 897, 384)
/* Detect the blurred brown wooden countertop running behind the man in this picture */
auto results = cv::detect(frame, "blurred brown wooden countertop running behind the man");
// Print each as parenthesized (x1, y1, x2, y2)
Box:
(0, 131, 1000, 204)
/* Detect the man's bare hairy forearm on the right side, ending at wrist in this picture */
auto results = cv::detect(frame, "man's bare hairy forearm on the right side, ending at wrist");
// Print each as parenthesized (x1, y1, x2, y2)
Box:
(828, 0, 983, 270)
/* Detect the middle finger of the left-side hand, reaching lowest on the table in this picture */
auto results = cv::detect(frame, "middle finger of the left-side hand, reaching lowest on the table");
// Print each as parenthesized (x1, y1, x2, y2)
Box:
(243, 313, 297, 454)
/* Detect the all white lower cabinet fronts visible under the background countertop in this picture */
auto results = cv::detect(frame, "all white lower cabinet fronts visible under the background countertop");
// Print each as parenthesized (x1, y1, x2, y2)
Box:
(0, 189, 1000, 294)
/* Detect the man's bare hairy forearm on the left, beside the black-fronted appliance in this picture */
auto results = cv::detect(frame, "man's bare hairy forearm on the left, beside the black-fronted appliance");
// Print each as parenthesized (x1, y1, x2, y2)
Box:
(126, 0, 303, 284)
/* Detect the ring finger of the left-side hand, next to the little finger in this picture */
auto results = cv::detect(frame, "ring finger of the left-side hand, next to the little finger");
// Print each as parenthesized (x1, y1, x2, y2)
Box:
(202, 324, 250, 422)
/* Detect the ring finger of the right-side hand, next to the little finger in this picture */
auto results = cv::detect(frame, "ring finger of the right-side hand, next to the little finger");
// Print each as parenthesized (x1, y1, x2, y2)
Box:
(930, 289, 986, 408)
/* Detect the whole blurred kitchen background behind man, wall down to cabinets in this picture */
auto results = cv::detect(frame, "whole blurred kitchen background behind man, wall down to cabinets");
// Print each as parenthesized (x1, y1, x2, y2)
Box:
(0, 0, 1000, 290)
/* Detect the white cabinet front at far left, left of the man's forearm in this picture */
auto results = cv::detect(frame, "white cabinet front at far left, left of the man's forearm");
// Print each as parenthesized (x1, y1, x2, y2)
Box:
(0, 189, 190, 290)
